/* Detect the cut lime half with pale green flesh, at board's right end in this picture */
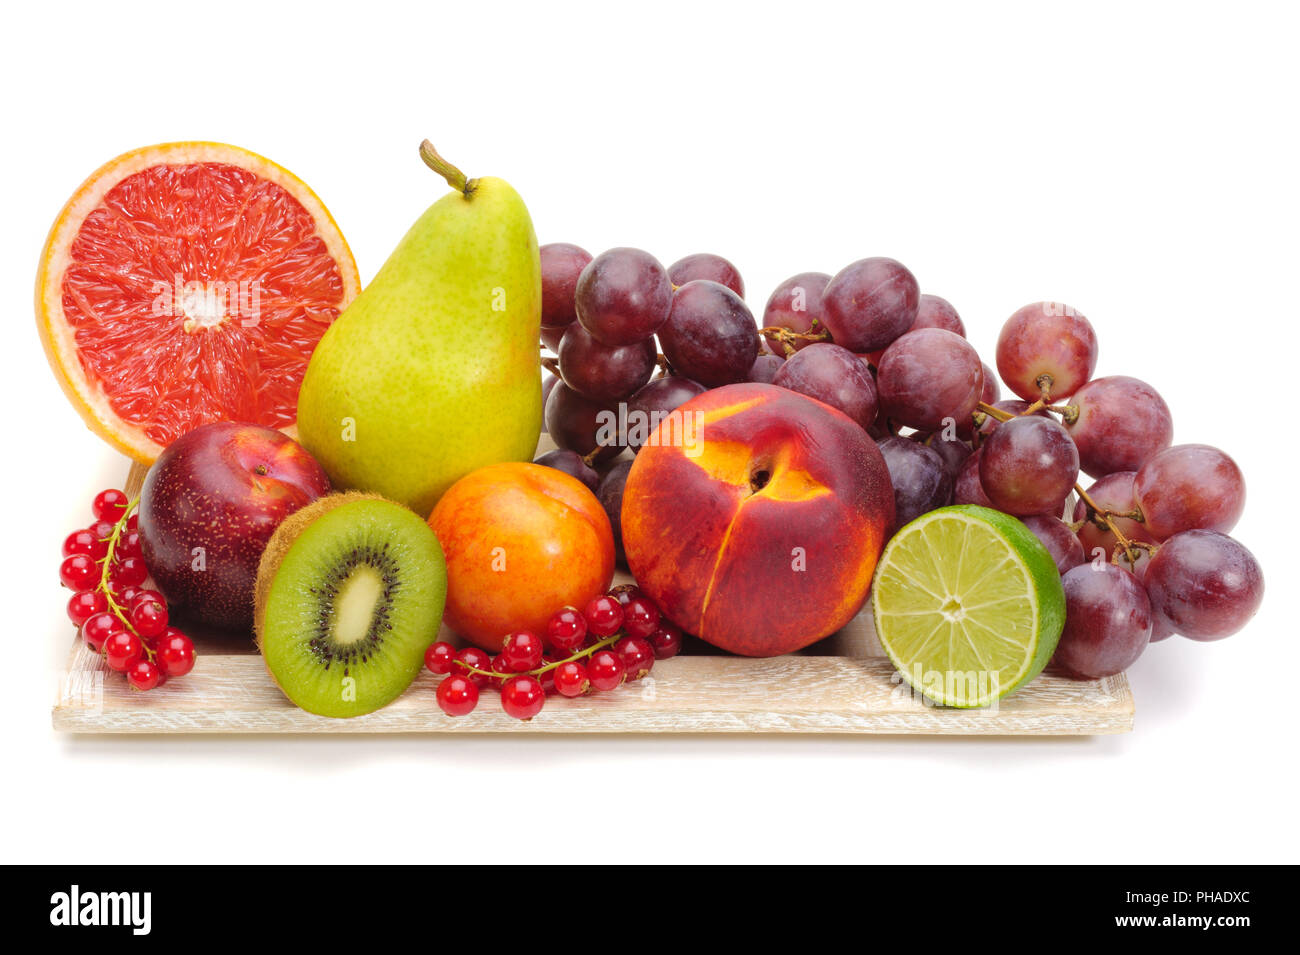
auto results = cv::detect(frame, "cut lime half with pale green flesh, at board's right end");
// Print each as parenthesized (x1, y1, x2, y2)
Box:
(874, 504, 1065, 707)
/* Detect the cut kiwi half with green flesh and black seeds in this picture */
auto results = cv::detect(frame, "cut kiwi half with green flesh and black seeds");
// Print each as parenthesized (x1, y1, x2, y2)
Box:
(254, 492, 447, 716)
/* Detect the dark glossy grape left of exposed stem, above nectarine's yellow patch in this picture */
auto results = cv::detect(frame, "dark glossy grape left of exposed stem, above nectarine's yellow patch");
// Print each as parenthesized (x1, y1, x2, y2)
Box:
(659, 279, 759, 388)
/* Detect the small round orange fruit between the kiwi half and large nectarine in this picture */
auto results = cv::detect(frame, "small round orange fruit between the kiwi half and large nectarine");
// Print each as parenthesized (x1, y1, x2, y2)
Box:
(429, 463, 614, 652)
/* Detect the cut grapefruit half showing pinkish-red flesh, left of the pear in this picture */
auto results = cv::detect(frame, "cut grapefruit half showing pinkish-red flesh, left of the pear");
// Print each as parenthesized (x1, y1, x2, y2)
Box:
(36, 143, 360, 464)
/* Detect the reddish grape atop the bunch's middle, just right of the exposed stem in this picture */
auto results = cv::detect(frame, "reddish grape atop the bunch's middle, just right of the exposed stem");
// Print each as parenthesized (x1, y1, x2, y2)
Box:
(822, 257, 920, 352)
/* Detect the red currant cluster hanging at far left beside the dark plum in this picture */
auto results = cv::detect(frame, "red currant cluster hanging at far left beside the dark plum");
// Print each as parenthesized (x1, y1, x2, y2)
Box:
(59, 489, 194, 690)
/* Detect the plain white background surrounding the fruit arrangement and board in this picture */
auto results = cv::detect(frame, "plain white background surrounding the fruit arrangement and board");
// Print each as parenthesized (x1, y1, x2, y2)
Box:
(0, 0, 1300, 864)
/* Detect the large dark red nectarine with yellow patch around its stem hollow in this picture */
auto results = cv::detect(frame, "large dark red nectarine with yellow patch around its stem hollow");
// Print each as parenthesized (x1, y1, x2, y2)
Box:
(623, 383, 894, 656)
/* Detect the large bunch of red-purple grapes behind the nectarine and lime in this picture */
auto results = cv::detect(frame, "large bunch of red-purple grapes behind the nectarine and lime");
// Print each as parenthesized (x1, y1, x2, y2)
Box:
(538, 243, 1264, 677)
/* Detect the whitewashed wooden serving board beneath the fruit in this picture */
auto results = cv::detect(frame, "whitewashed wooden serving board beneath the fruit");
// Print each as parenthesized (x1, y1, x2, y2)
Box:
(53, 466, 1134, 735)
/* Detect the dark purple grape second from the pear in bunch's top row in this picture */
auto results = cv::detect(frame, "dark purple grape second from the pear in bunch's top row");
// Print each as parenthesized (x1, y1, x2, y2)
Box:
(575, 248, 672, 346)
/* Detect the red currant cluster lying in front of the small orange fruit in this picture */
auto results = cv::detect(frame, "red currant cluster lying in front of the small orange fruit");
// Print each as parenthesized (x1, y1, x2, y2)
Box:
(424, 583, 681, 720)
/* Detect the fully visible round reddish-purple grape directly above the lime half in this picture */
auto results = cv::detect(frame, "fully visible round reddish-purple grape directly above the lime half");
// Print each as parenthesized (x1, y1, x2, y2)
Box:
(979, 414, 1079, 515)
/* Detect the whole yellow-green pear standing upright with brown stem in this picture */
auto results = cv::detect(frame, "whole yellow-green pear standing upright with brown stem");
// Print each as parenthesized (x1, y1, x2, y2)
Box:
(298, 140, 542, 516)
